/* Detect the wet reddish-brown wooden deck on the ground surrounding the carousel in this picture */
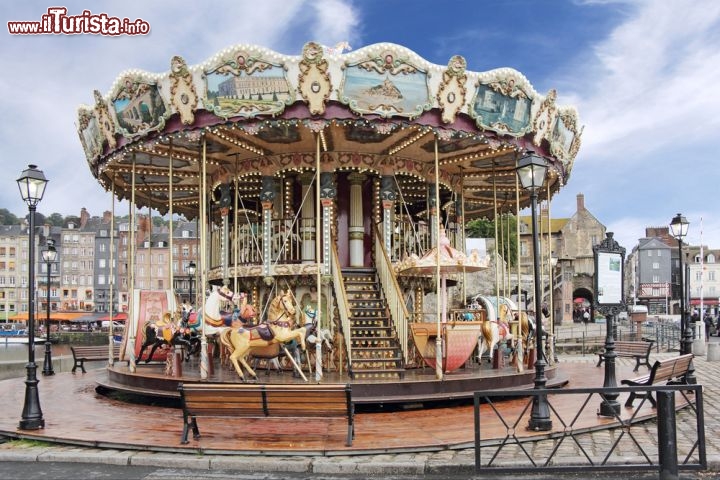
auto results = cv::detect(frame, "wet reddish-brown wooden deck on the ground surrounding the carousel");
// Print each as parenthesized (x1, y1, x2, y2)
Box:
(0, 358, 680, 456)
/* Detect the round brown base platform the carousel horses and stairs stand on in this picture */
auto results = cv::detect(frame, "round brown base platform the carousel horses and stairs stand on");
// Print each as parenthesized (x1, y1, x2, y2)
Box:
(98, 358, 569, 409)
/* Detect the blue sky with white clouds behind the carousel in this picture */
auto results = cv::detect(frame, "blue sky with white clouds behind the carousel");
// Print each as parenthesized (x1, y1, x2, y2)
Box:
(0, 0, 720, 253)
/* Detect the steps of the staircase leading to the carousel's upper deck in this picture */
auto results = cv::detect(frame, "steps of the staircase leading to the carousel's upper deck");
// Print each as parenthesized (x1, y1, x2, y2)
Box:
(342, 268, 405, 380)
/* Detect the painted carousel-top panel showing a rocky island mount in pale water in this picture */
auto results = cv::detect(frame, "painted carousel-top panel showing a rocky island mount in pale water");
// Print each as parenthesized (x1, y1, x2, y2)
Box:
(340, 50, 432, 118)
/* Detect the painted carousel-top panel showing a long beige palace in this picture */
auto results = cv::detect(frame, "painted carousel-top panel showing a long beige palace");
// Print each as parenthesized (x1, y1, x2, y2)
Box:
(205, 50, 295, 118)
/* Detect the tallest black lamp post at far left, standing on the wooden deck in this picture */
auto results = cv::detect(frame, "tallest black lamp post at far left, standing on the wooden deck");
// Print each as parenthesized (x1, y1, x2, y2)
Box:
(17, 165, 47, 430)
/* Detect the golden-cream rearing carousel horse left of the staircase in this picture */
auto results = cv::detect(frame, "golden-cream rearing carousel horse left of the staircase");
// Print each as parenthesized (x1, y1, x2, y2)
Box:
(220, 290, 306, 380)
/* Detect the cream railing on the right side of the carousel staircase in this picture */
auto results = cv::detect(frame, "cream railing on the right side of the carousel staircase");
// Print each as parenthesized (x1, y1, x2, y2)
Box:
(373, 226, 410, 364)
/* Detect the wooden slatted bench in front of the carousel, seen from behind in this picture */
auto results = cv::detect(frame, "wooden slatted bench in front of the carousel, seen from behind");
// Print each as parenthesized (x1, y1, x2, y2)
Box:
(178, 383, 355, 447)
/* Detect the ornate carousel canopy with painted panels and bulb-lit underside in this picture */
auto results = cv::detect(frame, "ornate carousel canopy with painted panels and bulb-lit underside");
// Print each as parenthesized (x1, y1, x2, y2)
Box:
(78, 42, 582, 218)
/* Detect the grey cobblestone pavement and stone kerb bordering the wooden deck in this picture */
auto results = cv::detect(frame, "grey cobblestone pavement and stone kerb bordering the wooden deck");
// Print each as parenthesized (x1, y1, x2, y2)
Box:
(0, 339, 720, 479)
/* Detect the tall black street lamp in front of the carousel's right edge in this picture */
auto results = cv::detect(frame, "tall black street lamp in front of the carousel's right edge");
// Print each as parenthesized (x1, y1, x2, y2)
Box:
(516, 152, 552, 431)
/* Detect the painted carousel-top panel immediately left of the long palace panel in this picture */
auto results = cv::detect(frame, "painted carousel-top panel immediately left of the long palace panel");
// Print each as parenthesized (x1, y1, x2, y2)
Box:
(112, 75, 168, 137)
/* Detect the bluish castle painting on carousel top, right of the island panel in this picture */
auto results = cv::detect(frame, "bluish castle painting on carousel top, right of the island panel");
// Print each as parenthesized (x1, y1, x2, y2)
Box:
(470, 77, 532, 136)
